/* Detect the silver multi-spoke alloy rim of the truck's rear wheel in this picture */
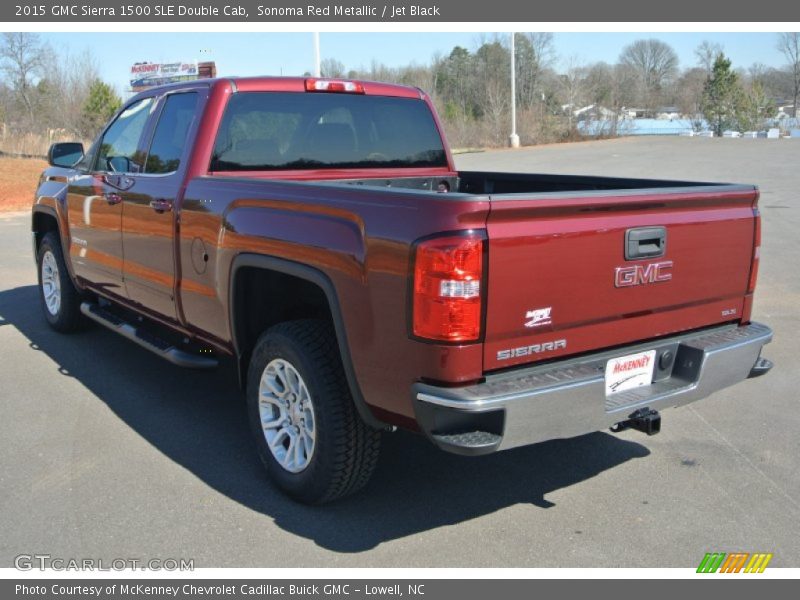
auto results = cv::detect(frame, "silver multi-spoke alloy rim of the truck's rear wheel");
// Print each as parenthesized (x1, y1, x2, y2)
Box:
(258, 358, 317, 473)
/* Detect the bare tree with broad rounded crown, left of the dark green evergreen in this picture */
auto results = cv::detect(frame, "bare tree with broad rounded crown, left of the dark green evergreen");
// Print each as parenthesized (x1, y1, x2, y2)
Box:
(619, 39, 678, 109)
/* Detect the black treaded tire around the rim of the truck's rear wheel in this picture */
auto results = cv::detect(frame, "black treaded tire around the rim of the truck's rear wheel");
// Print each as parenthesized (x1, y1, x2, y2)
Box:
(247, 319, 381, 504)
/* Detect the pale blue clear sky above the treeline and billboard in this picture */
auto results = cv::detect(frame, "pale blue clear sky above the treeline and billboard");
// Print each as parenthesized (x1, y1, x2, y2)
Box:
(40, 32, 785, 92)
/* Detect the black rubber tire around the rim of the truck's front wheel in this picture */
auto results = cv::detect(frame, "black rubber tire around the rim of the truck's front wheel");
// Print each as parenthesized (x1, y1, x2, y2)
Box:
(36, 231, 87, 333)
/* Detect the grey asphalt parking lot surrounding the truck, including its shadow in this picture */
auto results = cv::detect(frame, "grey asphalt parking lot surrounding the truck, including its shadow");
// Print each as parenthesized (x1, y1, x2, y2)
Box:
(0, 138, 800, 567)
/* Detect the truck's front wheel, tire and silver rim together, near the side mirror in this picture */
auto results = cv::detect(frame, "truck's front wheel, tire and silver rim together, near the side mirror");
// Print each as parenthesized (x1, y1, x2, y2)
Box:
(36, 231, 86, 333)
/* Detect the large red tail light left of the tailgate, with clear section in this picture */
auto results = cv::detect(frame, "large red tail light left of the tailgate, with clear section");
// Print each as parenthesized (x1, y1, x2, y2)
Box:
(412, 231, 485, 342)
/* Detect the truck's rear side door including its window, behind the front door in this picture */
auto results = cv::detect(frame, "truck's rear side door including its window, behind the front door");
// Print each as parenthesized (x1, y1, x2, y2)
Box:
(122, 90, 205, 319)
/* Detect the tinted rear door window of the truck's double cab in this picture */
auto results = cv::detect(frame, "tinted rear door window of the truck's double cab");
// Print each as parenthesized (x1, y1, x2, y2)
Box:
(145, 92, 197, 173)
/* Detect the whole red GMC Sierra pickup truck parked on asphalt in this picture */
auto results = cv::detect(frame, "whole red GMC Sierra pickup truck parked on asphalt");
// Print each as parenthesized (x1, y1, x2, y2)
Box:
(32, 77, 772, 503)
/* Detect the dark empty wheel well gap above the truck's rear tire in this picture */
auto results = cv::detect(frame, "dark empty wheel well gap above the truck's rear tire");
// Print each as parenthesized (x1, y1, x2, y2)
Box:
(231, 267, 333, 374)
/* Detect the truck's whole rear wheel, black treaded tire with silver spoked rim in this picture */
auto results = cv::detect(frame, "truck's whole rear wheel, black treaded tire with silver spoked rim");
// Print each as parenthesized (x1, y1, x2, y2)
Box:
(247, 319, 381, 504)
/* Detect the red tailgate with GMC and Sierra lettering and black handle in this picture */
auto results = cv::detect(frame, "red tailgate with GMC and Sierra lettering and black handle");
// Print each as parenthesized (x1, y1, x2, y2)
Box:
(484, 185, 758, 371)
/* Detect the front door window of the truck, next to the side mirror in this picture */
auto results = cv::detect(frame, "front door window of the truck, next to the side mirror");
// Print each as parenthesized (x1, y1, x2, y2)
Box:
(95, 98, 153, 173)
